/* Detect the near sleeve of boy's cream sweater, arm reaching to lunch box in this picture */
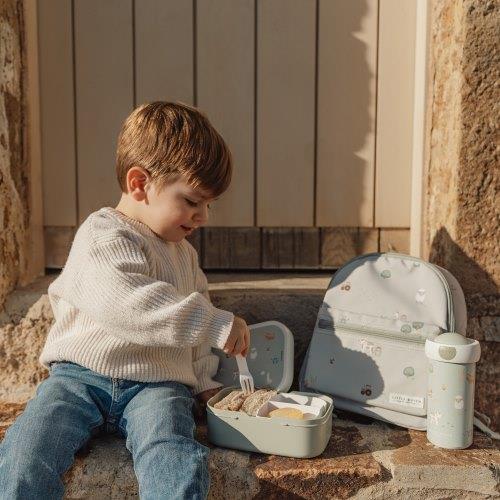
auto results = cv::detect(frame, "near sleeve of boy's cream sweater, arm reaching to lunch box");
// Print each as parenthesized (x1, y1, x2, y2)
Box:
(62, 234, 234, 348)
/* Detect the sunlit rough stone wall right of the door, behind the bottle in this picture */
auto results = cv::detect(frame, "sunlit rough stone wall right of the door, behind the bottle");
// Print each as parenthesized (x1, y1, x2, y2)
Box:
(424, 0, 500, 429)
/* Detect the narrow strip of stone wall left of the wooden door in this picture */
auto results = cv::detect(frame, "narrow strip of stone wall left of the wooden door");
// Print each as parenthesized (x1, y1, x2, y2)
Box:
(0, 0, 30, 309)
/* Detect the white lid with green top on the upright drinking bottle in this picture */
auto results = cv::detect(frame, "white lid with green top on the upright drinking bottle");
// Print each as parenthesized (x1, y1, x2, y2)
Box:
(425, 332, 481, 364)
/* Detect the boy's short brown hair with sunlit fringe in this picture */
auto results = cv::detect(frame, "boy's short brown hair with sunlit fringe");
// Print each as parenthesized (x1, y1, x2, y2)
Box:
(116, 101, 232, 198)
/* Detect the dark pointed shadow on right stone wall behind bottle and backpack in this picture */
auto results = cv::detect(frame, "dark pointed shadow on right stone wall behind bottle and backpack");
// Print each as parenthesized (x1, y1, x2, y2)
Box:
(429, 227, 500, 430)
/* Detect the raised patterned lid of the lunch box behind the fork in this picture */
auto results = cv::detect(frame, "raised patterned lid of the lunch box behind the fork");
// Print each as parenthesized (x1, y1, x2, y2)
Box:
(213, 321, 294, 392)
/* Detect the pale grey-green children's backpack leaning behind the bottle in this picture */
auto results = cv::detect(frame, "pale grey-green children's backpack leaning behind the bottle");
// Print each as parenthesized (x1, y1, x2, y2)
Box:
(299, 253, 467, 430)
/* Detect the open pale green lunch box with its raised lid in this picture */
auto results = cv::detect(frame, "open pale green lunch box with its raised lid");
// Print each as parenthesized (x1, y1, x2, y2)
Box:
(207, 321, 333, 458)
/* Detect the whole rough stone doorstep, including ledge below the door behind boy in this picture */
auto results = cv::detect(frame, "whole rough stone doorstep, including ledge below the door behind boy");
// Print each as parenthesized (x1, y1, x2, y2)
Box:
(0, 273, 500, 500)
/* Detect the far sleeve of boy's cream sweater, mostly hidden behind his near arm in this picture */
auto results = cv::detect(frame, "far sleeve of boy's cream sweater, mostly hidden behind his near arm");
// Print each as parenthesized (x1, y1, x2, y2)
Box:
(189, 251, 223, 394)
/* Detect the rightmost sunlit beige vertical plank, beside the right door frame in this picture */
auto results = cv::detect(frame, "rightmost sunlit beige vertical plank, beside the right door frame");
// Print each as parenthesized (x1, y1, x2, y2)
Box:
(375, 0, 416, 227)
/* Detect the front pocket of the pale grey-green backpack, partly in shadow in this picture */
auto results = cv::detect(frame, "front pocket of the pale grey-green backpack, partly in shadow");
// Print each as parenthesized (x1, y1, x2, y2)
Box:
(304, 317, 439, 416)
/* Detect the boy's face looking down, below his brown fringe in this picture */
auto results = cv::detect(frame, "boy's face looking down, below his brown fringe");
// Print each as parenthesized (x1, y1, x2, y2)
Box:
(143, 177, 214, 242)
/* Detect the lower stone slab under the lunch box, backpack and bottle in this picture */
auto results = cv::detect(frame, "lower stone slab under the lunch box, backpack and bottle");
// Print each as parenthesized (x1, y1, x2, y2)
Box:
(0, 403, 500, 500)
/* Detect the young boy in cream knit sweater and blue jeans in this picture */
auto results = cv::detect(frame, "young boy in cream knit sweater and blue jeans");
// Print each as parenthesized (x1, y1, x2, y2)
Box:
(0, 102, 250, 500)
